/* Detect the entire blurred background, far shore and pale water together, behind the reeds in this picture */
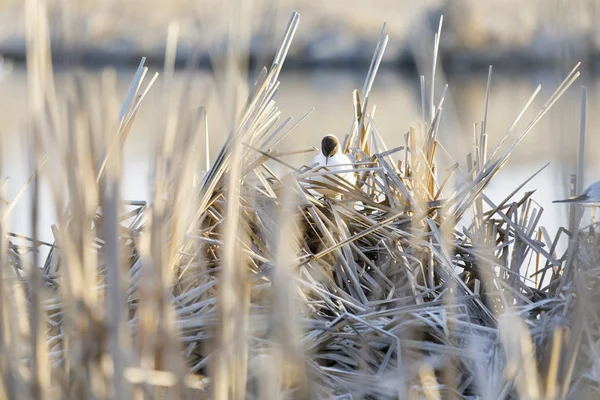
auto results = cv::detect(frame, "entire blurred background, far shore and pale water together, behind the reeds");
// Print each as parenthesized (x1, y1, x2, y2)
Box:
(0, 0, 600, 244)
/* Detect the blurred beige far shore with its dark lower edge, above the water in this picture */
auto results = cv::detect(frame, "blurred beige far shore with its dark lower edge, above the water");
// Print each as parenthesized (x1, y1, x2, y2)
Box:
(0, 0, 600, 71)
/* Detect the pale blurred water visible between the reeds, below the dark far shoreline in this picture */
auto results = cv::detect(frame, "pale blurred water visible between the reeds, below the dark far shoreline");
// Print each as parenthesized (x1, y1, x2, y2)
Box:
(0, 69, 600, 256)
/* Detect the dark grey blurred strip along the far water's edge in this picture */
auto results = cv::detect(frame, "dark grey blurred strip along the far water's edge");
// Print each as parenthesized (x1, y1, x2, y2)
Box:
(0, 42, 600, 73)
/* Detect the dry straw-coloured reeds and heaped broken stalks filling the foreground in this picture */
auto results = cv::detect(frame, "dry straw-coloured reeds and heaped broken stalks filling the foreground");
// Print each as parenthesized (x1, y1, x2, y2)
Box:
(0, 2, 600, 400)
